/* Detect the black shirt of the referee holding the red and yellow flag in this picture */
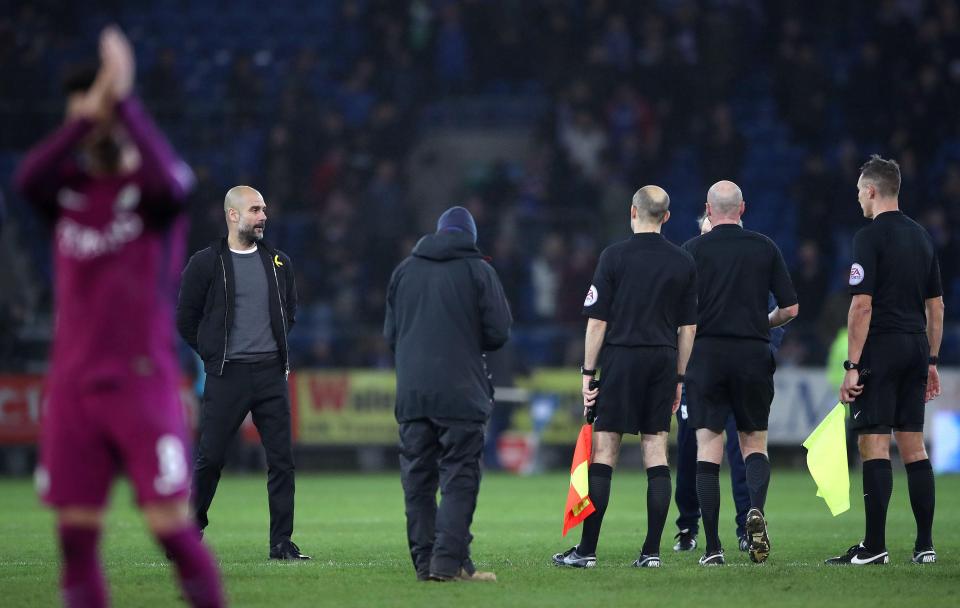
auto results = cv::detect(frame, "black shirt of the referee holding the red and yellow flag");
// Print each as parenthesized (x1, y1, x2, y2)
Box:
(583, 232, 697, 348)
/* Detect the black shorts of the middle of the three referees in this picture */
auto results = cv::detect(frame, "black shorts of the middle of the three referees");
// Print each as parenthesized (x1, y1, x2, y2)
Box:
(686, 338, 777, 433)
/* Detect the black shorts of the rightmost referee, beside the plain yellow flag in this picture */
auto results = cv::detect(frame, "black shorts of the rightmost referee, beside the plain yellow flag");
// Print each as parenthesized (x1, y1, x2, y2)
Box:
(850, 334, 930, 435)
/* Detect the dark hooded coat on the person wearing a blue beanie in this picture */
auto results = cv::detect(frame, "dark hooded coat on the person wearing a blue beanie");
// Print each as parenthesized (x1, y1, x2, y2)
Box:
(383, 231, 513, 422)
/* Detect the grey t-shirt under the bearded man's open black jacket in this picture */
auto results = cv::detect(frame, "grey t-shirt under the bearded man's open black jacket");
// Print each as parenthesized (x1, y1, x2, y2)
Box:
(227, 250, 280, 362)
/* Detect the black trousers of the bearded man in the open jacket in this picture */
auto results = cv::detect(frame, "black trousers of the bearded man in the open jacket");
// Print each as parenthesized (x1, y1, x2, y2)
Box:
(193, 359, 294, 547)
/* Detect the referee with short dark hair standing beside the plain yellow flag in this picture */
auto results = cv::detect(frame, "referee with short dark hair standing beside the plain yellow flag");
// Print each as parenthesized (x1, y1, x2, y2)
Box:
(827, 155, 943, 566)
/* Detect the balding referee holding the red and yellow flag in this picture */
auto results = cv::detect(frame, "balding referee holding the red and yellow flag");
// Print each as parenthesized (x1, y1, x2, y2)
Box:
(553, 186, 697, 568)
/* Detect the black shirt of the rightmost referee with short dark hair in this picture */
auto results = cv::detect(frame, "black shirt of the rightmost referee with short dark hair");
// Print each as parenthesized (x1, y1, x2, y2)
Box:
(850, 210, 943, 336)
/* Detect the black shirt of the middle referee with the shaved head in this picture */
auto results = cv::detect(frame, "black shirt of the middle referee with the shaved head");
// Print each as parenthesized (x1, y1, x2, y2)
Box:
(683, 224, 797, 342)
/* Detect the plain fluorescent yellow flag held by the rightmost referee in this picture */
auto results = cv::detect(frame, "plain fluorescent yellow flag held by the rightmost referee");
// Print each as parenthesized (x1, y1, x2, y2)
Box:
(803, 403, 850, 516)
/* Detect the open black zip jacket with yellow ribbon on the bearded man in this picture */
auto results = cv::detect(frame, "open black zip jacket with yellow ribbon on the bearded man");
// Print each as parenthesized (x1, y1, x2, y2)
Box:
(177, 238, 297, 376)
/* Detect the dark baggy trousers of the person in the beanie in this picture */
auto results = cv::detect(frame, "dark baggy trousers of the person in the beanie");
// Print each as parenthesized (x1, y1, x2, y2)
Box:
(400, 418, 483, 579)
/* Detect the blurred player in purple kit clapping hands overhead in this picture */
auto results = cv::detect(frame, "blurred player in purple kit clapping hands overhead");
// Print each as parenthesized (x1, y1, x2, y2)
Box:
(16, 27, 224, 606)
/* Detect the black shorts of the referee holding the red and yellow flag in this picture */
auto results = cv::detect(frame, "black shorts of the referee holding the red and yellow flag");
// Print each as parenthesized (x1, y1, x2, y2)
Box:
(593, 344, 677, 435)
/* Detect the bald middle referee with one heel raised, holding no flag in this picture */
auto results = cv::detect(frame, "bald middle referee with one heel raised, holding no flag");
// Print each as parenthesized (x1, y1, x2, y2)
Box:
(683, 181, 800, 566)
